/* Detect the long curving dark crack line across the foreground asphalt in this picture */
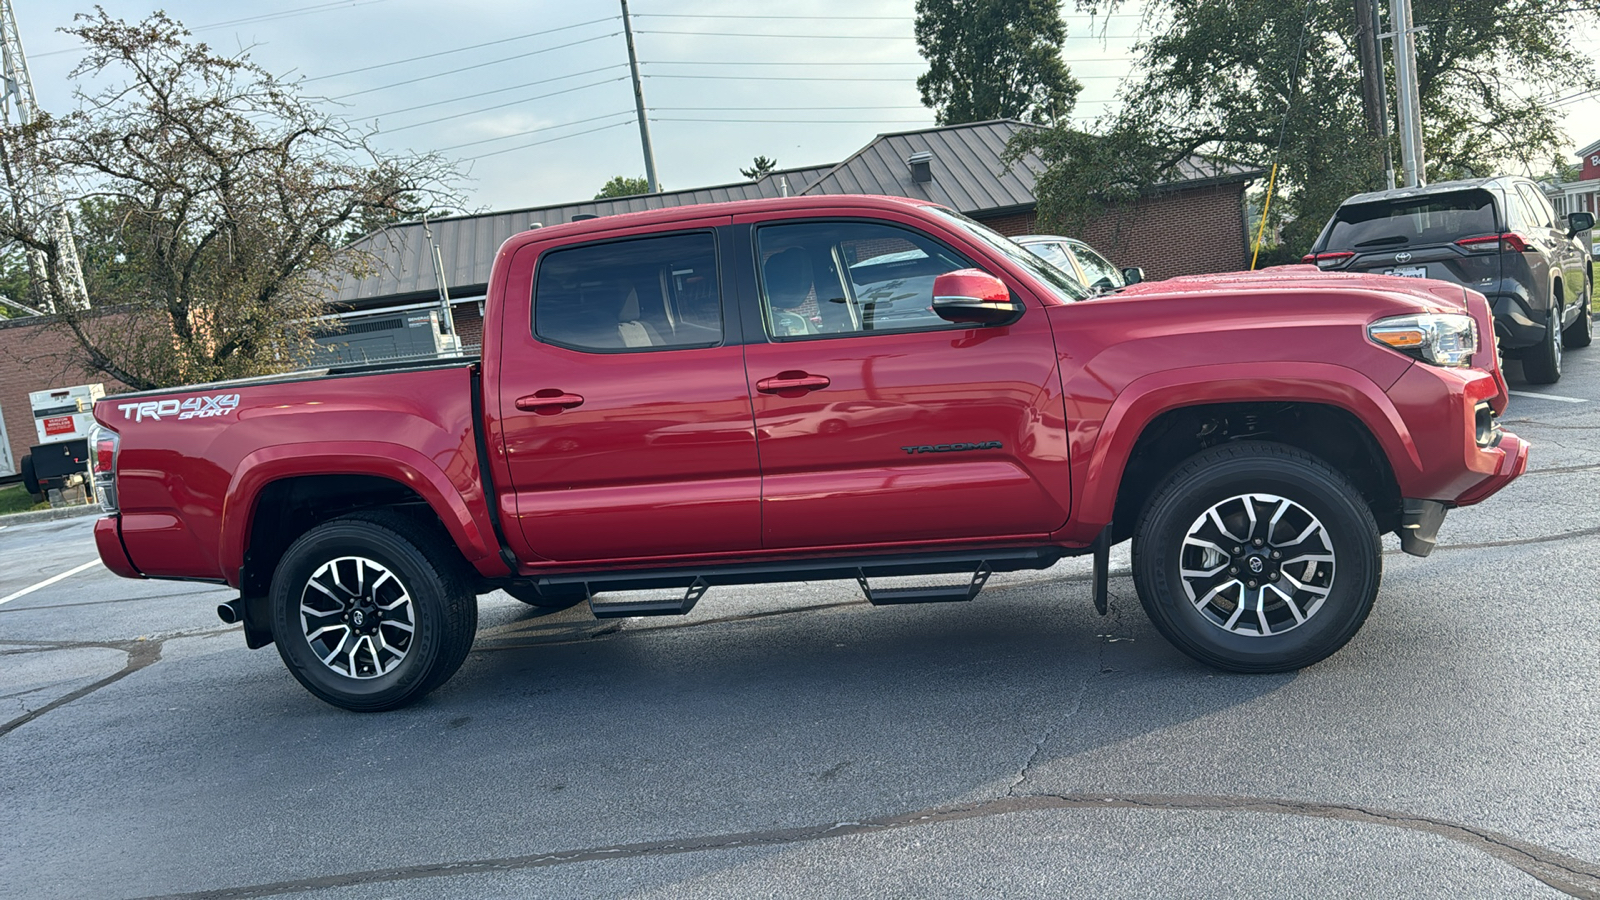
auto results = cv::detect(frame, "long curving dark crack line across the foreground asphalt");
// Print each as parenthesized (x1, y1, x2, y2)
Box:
(121, 793, 1600, 900)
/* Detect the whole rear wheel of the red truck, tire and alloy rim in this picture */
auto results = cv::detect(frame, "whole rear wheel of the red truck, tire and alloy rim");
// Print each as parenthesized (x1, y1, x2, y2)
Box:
(269, 512, 478, 713)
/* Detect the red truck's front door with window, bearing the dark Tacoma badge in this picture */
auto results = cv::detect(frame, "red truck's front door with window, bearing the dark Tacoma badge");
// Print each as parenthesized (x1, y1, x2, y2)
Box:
(734, 218, 1069, 548)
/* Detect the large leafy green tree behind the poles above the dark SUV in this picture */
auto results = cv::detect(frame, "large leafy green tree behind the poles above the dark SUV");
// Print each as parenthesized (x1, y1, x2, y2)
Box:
(1011, 0, 1600, 253)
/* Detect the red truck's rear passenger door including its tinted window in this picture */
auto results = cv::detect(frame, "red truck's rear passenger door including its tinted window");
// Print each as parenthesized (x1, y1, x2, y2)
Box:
(491, 218, 760, 562)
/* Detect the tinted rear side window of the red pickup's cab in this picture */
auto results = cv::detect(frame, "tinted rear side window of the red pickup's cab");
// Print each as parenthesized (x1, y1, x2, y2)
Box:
(533, 232, 722, 352)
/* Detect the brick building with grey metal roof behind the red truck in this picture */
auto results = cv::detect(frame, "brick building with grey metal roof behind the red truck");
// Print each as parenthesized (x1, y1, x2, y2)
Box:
(0, 120, 1262, 470)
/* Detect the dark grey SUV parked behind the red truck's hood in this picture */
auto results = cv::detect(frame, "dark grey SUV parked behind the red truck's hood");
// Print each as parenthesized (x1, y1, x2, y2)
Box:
(1306, 176, 1595, 384)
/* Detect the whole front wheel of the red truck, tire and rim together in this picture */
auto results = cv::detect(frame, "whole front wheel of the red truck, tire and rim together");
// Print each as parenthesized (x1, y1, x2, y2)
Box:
(1133, 440, 1382, 673)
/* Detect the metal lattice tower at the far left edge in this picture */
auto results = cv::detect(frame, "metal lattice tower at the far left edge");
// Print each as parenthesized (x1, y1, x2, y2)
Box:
(0, 0, 90, 312)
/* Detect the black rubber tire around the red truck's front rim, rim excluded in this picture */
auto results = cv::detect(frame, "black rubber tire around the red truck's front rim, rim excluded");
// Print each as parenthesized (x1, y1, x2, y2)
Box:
(1133, 445, 1382, 671)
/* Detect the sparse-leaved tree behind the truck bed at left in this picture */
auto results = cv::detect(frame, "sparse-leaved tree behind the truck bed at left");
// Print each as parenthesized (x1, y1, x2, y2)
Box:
(0, 10, 454, 388)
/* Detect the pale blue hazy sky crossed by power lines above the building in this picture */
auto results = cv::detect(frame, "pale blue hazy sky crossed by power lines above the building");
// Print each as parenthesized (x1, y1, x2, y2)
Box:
(13, 0, 1600, 211)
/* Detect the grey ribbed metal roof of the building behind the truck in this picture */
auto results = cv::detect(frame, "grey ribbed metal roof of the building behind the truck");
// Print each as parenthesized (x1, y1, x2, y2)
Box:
(333, 119, 1262, 306)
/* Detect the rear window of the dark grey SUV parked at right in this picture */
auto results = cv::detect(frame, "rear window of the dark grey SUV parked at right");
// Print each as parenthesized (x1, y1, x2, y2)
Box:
(1323, 191, 1501, 250)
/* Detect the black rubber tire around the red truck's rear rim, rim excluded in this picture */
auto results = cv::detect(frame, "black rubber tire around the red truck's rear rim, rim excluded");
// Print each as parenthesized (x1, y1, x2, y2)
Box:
(270, 520, 445, 711)
